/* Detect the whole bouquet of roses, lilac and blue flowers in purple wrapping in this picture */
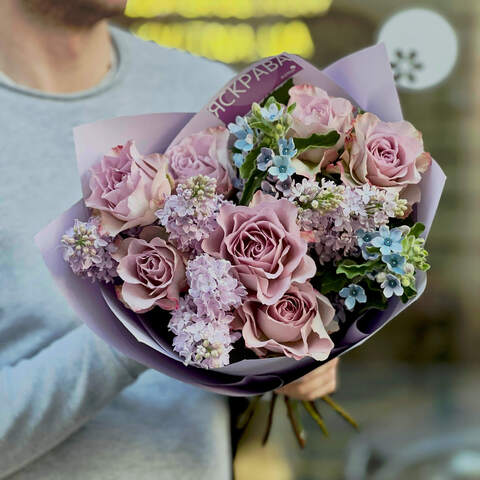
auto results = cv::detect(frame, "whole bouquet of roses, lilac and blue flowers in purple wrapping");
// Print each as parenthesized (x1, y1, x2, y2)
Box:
(37, 46, 445, 446)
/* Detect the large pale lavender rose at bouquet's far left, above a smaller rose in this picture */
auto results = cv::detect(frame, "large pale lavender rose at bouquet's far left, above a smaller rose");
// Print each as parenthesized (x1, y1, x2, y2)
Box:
(85, 140, 171, 237)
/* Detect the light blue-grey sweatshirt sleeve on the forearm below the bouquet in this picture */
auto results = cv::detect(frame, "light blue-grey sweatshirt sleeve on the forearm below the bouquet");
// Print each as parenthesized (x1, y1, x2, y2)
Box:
(0, 326, 145, 479)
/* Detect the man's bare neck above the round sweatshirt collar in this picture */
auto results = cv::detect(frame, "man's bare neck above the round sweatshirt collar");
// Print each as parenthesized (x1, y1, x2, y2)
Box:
(0, 0, 112, 93)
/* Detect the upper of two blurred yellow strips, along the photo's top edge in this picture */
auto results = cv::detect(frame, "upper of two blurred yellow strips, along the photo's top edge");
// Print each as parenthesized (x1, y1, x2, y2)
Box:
(125, 0, 332, 19)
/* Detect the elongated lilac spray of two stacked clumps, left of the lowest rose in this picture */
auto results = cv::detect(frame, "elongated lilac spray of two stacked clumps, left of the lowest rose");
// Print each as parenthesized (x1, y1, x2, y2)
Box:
(169, 254, 246, 368)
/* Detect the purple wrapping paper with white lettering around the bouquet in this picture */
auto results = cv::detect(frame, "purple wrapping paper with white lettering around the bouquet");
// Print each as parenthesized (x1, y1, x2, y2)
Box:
(35, 45, 445, 396)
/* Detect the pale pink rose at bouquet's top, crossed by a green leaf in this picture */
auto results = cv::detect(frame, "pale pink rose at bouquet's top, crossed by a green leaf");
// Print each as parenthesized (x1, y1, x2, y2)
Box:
(288, 85, 353, 177)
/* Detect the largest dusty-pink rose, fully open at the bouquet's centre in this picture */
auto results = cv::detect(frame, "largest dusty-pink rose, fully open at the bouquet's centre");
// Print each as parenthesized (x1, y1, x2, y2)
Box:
(202, 191, 316, 305)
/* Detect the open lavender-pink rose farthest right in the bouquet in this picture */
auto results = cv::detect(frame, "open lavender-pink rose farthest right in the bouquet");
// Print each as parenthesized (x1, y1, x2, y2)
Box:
(341, 113, 432, 203)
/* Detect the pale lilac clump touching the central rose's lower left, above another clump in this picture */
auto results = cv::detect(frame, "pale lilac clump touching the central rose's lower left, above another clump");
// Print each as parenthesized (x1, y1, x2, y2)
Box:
(187, 254, 247, 320)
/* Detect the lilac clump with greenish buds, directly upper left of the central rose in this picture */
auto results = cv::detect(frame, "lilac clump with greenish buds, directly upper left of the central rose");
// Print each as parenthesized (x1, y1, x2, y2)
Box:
(156, 175, 227, 254)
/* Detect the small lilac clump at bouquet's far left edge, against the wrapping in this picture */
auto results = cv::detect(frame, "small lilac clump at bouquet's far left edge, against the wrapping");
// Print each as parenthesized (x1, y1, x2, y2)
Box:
(61, 217, 118, 283)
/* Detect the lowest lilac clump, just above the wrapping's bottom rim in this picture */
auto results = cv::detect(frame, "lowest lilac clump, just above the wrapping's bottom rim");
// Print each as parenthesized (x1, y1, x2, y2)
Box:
(168, 295, 241, 368)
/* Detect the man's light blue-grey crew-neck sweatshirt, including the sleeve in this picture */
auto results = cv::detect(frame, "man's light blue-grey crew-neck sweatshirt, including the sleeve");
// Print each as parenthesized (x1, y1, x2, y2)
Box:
(0, 29, 233, 480)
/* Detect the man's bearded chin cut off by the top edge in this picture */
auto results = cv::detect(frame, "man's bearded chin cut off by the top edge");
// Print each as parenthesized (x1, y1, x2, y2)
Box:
(21, 0, 126, 28)
